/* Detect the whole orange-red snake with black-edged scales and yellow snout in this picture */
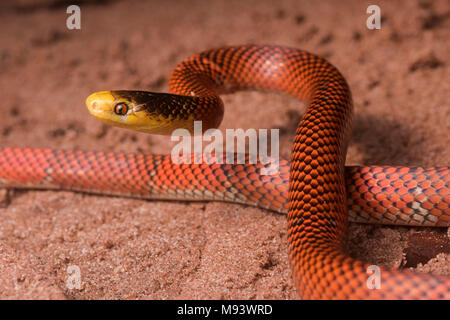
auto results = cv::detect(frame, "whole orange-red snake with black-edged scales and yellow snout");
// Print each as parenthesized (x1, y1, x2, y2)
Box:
(0, 45, 450, 299)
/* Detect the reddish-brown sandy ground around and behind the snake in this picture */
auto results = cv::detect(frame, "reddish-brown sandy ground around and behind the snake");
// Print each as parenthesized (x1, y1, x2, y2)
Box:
(0, 0, 450, 299)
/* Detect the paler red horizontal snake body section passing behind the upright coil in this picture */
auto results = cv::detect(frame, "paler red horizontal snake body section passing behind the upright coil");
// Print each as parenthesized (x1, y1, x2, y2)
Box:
(0, 147, 450, 227)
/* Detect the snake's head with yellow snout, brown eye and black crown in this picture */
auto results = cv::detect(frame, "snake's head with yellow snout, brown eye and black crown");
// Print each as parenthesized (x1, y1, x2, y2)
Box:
(86, 90, 197, 135)
